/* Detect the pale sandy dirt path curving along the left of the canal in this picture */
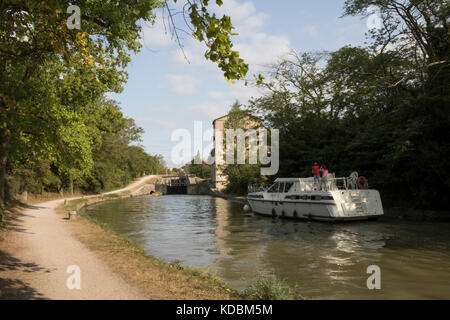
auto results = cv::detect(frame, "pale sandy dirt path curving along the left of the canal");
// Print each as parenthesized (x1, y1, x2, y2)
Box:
(0, 176, 154, 299)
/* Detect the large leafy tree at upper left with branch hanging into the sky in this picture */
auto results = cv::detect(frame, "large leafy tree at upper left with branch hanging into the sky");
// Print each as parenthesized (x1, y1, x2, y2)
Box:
(0, 0, 248, 204)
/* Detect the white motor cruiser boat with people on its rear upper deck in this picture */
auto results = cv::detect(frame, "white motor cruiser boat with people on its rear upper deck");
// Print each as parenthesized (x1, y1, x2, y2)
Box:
(247, 172, 383, 221)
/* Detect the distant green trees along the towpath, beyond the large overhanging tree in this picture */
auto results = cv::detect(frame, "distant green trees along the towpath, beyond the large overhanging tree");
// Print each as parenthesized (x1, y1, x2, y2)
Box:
(3, 100, 164, 196)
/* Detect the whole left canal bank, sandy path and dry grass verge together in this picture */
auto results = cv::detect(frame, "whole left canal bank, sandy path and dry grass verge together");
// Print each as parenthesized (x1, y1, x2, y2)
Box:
(0, 180, 243, 299)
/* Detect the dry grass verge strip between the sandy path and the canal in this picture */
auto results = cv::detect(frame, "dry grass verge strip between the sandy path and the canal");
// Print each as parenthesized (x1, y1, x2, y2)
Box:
(57, 197, 242, 300)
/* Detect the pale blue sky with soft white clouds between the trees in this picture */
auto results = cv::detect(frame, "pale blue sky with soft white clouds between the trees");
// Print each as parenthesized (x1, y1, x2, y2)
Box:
(110, 0, 367, 167)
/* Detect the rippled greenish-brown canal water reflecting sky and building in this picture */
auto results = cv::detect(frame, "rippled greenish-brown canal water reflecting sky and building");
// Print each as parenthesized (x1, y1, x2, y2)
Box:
(81, 195, 450, 299)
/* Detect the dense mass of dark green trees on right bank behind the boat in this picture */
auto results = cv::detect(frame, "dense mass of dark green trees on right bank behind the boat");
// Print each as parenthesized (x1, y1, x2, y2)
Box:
(247, 0, 450, 209)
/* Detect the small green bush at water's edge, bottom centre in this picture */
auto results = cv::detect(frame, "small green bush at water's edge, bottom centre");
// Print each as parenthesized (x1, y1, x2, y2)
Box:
(243, 275, 295, 300)
